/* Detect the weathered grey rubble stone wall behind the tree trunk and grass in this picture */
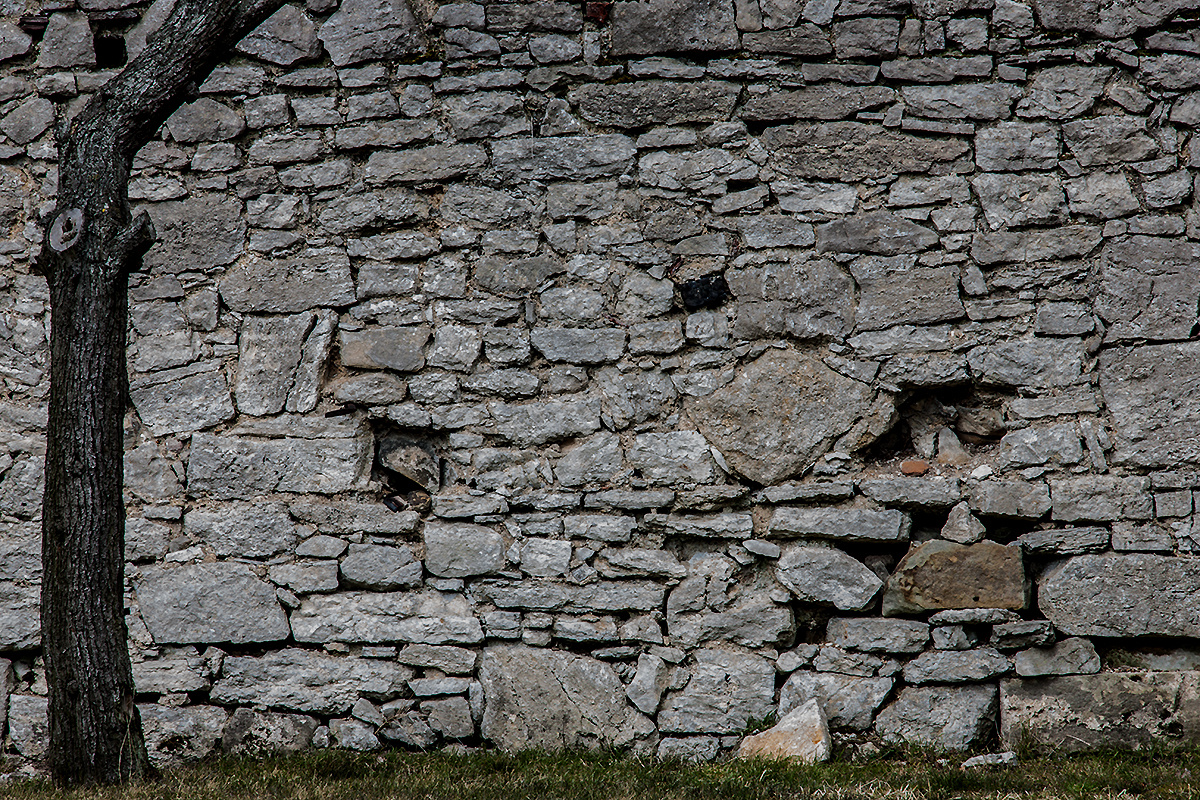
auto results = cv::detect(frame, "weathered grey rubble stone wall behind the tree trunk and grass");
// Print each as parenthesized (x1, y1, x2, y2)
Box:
(0, 0, 1200, 763)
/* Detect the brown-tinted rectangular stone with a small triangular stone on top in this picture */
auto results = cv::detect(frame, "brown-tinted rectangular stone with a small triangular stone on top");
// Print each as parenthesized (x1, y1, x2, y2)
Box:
(883, 540, 1028, 616)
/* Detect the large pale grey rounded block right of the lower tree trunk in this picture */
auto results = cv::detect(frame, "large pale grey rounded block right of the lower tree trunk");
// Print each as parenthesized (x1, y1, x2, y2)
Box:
(137, 564, 288, 644)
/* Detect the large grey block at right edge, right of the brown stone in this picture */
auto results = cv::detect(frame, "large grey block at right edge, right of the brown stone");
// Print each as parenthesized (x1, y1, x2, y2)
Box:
(1038, 553, 1200, 637)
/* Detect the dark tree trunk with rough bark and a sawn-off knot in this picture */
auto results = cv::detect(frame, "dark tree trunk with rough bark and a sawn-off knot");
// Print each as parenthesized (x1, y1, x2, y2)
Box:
(40, 0, 282, 787)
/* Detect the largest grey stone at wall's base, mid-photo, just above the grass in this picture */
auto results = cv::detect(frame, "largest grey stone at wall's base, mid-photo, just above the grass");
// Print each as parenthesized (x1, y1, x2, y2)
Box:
(479, 645, 654, 751)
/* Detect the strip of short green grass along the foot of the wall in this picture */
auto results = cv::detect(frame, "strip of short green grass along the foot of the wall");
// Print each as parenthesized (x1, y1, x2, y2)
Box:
(9, 750, 1200, 800)
